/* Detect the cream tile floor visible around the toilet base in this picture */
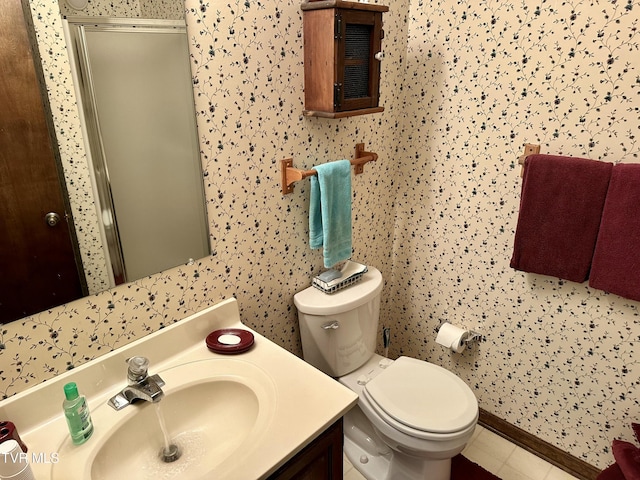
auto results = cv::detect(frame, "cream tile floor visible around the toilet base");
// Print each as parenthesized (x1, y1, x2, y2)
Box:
(344, 425, 577, 480)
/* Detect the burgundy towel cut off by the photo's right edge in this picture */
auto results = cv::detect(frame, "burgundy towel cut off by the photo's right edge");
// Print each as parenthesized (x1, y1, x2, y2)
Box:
(589, 163, 640, 300)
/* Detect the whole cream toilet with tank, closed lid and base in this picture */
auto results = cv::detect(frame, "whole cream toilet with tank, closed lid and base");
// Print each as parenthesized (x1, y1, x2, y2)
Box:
(294, 267, 478, 480)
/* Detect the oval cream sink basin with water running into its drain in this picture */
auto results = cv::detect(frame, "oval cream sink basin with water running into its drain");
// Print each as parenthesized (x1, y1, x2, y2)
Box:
(52, 359, 275, 480)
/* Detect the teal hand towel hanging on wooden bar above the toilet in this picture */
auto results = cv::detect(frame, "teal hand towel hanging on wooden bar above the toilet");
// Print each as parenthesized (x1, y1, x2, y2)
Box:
(309, 160, 351, 268)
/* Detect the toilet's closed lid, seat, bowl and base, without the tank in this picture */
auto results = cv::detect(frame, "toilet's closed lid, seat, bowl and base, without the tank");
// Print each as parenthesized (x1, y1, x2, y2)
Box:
(338, 355, 478, 480)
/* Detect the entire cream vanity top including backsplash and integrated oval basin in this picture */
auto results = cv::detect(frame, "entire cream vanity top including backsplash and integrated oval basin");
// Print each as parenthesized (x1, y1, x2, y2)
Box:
(0, 299, 358, 480)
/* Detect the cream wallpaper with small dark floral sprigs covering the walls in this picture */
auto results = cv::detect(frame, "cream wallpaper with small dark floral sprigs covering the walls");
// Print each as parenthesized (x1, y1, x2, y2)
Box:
(0, 0, 640, 467)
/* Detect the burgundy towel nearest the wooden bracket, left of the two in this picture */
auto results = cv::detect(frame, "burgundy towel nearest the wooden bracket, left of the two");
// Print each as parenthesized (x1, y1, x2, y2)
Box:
(511, 154, 613, 282)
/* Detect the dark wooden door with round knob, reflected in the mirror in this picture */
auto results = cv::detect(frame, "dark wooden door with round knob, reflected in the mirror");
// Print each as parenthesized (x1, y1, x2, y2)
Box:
(0, 0, 83, 323)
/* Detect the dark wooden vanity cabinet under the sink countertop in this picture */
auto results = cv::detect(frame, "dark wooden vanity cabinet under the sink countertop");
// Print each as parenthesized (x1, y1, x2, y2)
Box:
(269, 418, 343, 480)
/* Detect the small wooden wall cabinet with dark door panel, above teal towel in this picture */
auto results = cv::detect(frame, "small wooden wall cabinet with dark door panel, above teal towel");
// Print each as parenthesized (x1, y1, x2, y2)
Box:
(301, 0, 389, 118)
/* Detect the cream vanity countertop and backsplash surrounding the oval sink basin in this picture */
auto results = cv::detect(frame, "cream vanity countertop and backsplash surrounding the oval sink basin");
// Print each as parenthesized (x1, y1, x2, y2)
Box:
(0, 299, 358, 480)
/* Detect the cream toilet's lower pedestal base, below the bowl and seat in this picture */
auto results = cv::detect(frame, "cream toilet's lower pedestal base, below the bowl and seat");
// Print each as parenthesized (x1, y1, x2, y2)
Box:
(344, 407, 451, 480)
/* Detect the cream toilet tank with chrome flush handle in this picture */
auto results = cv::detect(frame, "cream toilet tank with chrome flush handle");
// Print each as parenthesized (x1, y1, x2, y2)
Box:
(293, 267, 382, 377)
